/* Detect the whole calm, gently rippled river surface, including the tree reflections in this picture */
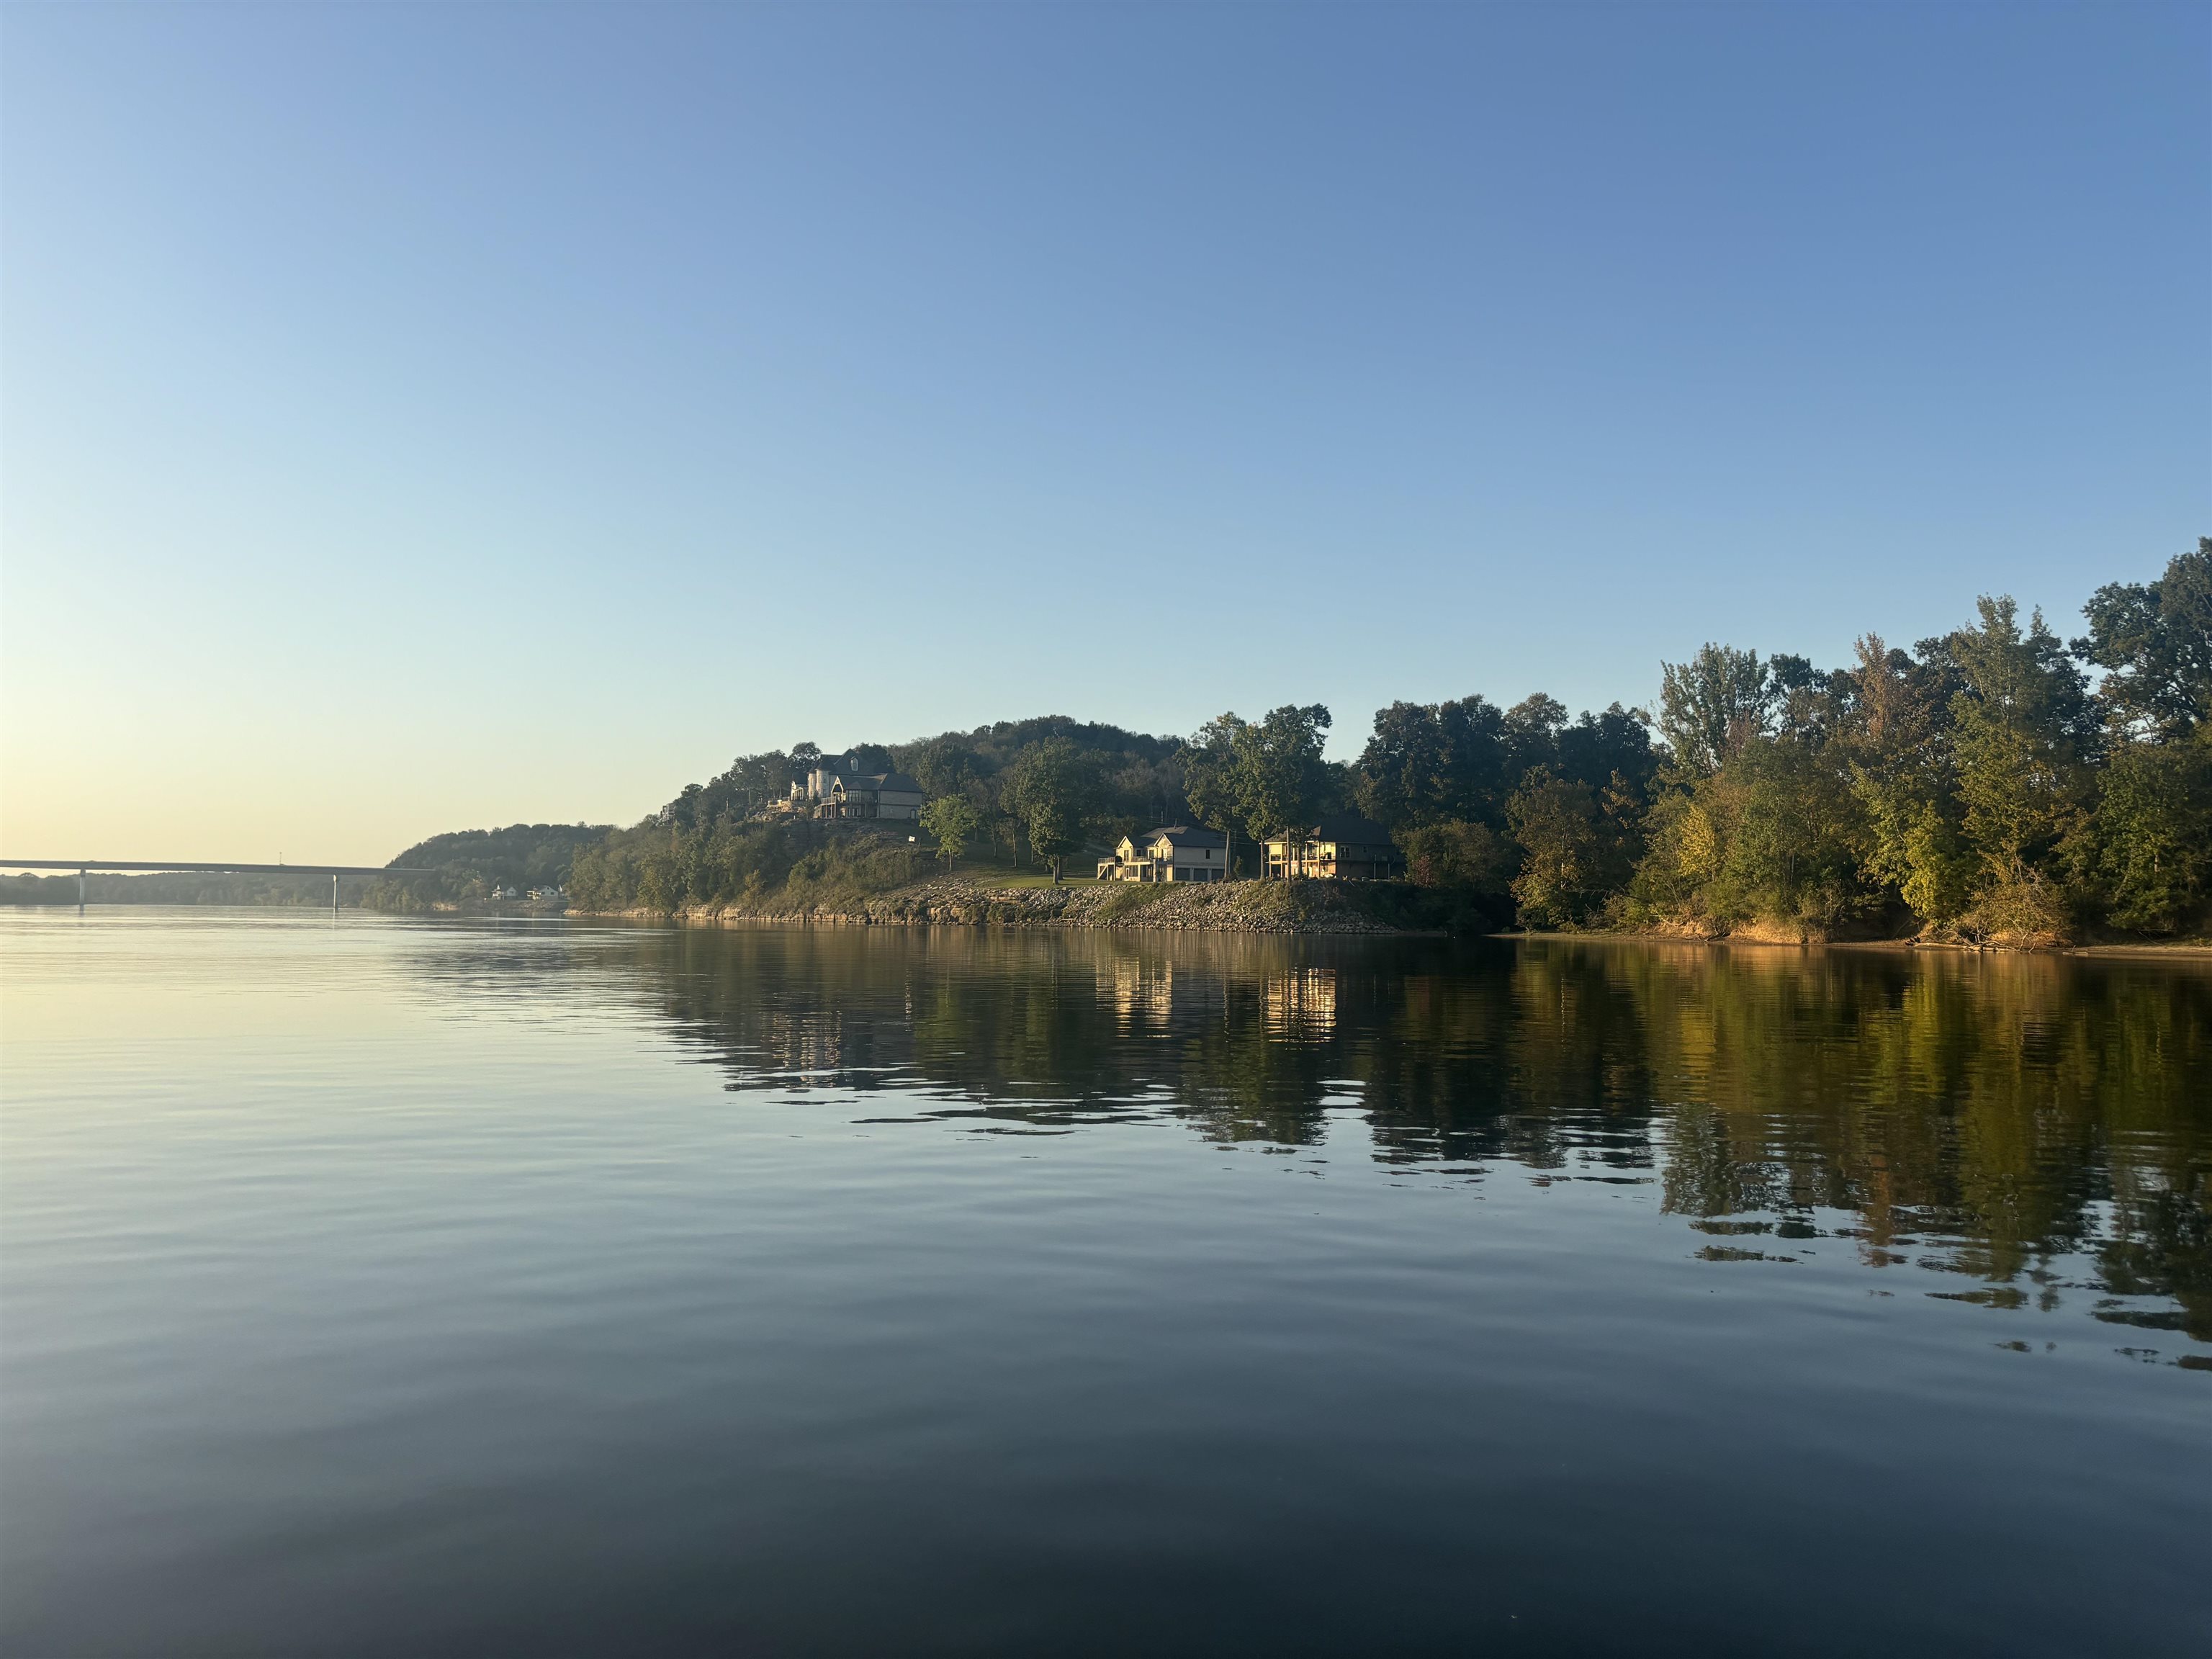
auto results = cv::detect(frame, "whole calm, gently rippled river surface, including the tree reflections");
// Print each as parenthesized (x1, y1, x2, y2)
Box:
(0, 912, 2212, 1655)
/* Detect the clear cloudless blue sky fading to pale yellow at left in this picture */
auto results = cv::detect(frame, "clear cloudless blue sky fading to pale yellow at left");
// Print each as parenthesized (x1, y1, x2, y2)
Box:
(0, 4, 2212, 860)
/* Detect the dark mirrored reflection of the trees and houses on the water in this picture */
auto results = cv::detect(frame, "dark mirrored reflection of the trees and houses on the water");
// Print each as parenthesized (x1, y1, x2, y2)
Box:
(557, 929, 2212, 1341)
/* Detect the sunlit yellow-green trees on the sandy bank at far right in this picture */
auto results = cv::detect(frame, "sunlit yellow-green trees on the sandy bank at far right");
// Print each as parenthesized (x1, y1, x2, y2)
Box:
(1630, 559, 2203, 943)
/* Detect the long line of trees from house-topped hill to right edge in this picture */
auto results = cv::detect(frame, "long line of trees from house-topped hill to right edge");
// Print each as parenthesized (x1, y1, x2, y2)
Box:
(569, 540, 2212, 943)
